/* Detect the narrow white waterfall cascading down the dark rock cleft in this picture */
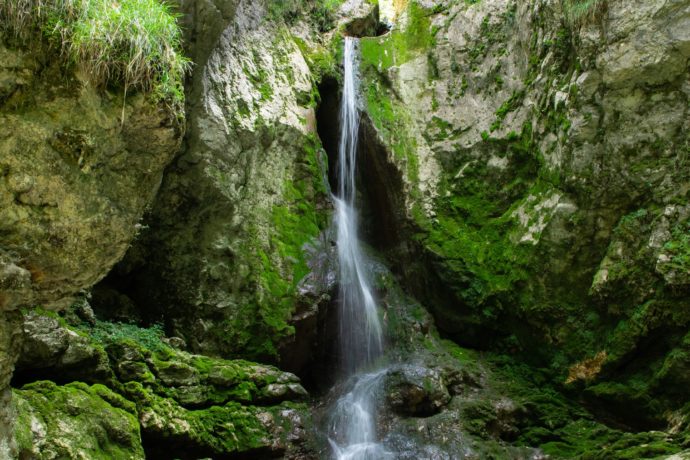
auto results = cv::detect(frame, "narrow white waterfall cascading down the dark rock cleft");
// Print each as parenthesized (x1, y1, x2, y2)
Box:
(328, 37, 390, 460)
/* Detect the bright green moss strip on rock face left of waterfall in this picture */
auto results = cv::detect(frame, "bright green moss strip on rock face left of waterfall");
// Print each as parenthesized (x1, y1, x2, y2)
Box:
(200, 136, 329, 360)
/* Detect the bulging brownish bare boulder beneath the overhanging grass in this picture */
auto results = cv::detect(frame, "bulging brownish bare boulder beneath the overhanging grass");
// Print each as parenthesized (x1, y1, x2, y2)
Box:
(0, 37, 181, 310)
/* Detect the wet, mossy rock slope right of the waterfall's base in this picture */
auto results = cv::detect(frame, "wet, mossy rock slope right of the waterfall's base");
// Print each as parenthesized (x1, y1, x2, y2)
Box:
(358, 265, 689, 460)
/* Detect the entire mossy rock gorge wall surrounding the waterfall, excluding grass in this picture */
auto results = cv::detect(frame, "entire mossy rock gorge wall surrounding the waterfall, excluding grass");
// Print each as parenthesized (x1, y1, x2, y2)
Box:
(0, 0, 690, 459)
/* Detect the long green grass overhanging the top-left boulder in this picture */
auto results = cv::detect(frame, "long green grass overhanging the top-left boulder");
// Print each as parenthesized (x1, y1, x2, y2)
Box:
(0, 0, 190, 102)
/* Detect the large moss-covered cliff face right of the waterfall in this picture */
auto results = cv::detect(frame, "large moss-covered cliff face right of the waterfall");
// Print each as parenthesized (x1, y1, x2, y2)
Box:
(361, 0, 690, 427)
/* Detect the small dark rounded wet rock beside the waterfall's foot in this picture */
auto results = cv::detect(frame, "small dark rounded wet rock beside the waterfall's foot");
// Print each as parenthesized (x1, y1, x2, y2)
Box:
(385, 365, 451, 417)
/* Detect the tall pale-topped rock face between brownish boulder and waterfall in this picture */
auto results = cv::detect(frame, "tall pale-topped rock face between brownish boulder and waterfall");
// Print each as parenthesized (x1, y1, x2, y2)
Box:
(107, 1, 329, 360)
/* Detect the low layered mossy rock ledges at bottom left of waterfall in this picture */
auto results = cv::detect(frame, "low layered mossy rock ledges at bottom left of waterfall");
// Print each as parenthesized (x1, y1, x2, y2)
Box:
(9, 311, 312, 459)
